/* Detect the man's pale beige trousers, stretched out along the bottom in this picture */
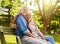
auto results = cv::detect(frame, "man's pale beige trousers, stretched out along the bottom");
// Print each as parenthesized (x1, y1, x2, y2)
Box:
(22, 36, 48, 44)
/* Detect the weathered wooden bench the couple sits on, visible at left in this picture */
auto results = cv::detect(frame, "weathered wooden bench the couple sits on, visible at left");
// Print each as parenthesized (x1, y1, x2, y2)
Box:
(0, 26, 21, 44)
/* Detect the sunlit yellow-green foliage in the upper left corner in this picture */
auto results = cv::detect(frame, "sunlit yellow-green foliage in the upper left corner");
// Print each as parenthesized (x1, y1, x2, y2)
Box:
(1, 0, 22, 16)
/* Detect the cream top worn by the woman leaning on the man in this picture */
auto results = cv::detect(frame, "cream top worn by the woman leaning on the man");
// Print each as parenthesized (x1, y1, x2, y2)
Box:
(29, 21, 43, 36)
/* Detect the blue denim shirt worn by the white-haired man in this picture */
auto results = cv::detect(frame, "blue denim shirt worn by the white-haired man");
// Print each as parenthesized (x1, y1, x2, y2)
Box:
(15, 15, 29, 38)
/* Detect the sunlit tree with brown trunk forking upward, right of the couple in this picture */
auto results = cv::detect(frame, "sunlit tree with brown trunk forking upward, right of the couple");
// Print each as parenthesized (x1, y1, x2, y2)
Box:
(22, 0, 59, 34)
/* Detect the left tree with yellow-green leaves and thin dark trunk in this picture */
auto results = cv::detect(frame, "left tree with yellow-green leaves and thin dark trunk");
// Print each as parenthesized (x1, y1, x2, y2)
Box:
(0, 0, 22, 26)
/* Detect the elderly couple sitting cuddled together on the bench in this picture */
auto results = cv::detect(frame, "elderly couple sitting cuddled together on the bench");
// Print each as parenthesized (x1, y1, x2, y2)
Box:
(13, 6, 54, 44)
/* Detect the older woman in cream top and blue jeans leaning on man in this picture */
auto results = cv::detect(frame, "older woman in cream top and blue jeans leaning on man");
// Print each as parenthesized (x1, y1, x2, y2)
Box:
(28, 14, 54, 44)
